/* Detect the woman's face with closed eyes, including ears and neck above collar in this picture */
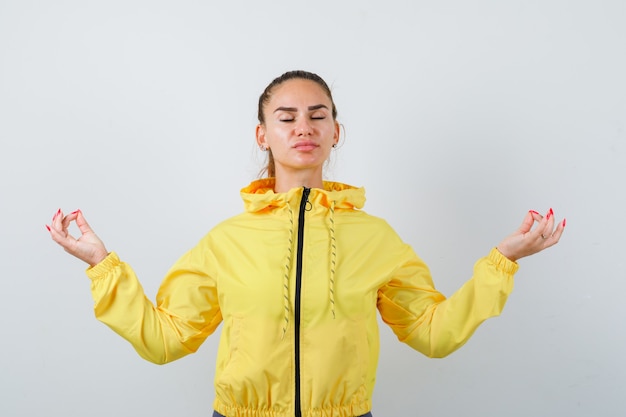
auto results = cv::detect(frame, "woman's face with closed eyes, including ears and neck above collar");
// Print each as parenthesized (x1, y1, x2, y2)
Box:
(256, 79, 339, 178)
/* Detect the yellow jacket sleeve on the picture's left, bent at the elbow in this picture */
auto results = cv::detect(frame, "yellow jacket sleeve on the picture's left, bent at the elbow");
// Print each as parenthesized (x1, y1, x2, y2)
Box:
(87, 239, 222, 364)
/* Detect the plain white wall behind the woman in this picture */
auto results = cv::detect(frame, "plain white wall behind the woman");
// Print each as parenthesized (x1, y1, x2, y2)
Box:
(0, 0, 626, 417)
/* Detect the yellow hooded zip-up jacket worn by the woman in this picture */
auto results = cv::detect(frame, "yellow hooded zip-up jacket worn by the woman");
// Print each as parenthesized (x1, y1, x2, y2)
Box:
(87, 179, 517, 417)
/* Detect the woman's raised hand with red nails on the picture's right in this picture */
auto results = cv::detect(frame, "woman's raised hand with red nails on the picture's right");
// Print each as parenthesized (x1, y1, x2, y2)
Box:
(497, 209, 565, 262)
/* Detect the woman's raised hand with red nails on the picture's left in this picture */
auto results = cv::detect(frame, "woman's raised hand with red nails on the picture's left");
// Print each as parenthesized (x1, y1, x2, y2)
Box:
(46, 209, 109, 266)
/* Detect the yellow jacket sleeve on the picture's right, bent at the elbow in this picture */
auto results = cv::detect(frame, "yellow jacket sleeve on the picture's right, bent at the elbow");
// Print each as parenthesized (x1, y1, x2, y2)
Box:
(378, 248, 518, 358)
